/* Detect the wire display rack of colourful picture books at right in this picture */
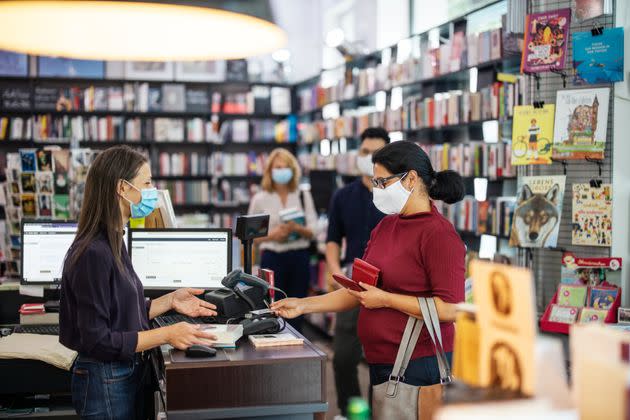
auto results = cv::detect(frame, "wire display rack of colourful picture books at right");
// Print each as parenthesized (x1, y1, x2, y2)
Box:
(510, 0, 624, 314)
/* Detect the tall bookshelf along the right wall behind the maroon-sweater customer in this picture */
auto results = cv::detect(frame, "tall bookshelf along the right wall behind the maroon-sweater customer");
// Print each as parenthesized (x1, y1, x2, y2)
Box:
(296, 3, 530, 331)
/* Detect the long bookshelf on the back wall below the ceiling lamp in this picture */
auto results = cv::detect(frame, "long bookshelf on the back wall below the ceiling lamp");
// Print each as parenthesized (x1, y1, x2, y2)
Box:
(0, 78, 296, 240)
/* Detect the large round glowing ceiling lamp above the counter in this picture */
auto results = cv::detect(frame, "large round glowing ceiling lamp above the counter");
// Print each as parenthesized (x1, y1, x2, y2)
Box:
(0, 0, 287, 61)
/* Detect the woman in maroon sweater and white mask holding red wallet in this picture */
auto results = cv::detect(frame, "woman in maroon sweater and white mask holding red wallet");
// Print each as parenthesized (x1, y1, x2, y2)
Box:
(272, 141, 466, 386)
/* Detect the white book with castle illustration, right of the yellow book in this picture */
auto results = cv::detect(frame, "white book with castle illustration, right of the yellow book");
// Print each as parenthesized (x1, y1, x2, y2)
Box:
(553, 87, 610, 160)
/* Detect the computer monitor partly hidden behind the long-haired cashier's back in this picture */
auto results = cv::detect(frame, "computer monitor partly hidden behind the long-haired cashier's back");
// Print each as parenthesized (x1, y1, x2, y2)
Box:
(21, 220, 128, 285)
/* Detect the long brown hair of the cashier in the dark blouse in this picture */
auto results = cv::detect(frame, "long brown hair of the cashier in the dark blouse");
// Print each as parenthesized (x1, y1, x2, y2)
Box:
(64, 146, 147, 271)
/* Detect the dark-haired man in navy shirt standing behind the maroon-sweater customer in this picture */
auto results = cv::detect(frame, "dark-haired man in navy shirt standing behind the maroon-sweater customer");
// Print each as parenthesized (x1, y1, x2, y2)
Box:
(326, 127, 389, 415)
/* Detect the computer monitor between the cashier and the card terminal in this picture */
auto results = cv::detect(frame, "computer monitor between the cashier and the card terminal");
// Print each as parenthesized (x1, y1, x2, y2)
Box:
(129, 229, 232, 289)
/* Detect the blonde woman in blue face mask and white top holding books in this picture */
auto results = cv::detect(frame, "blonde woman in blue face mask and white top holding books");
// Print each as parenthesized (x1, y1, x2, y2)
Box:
(248, 149, 317, 330)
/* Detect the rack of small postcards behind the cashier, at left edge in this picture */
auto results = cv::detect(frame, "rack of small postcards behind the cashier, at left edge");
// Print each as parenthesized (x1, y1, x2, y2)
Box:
(2, 148, 96, 276)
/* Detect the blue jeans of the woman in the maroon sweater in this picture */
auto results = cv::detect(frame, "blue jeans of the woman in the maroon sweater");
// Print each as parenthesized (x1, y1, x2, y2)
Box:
(370, 353, 453, 386)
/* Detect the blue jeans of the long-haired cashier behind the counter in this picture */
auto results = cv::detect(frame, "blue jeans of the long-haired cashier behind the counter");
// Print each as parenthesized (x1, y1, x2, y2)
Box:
(72, 354, 144, 420)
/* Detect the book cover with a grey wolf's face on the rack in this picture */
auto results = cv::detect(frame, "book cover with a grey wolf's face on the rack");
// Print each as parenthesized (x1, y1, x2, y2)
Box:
(510, 175, 566, 248)
